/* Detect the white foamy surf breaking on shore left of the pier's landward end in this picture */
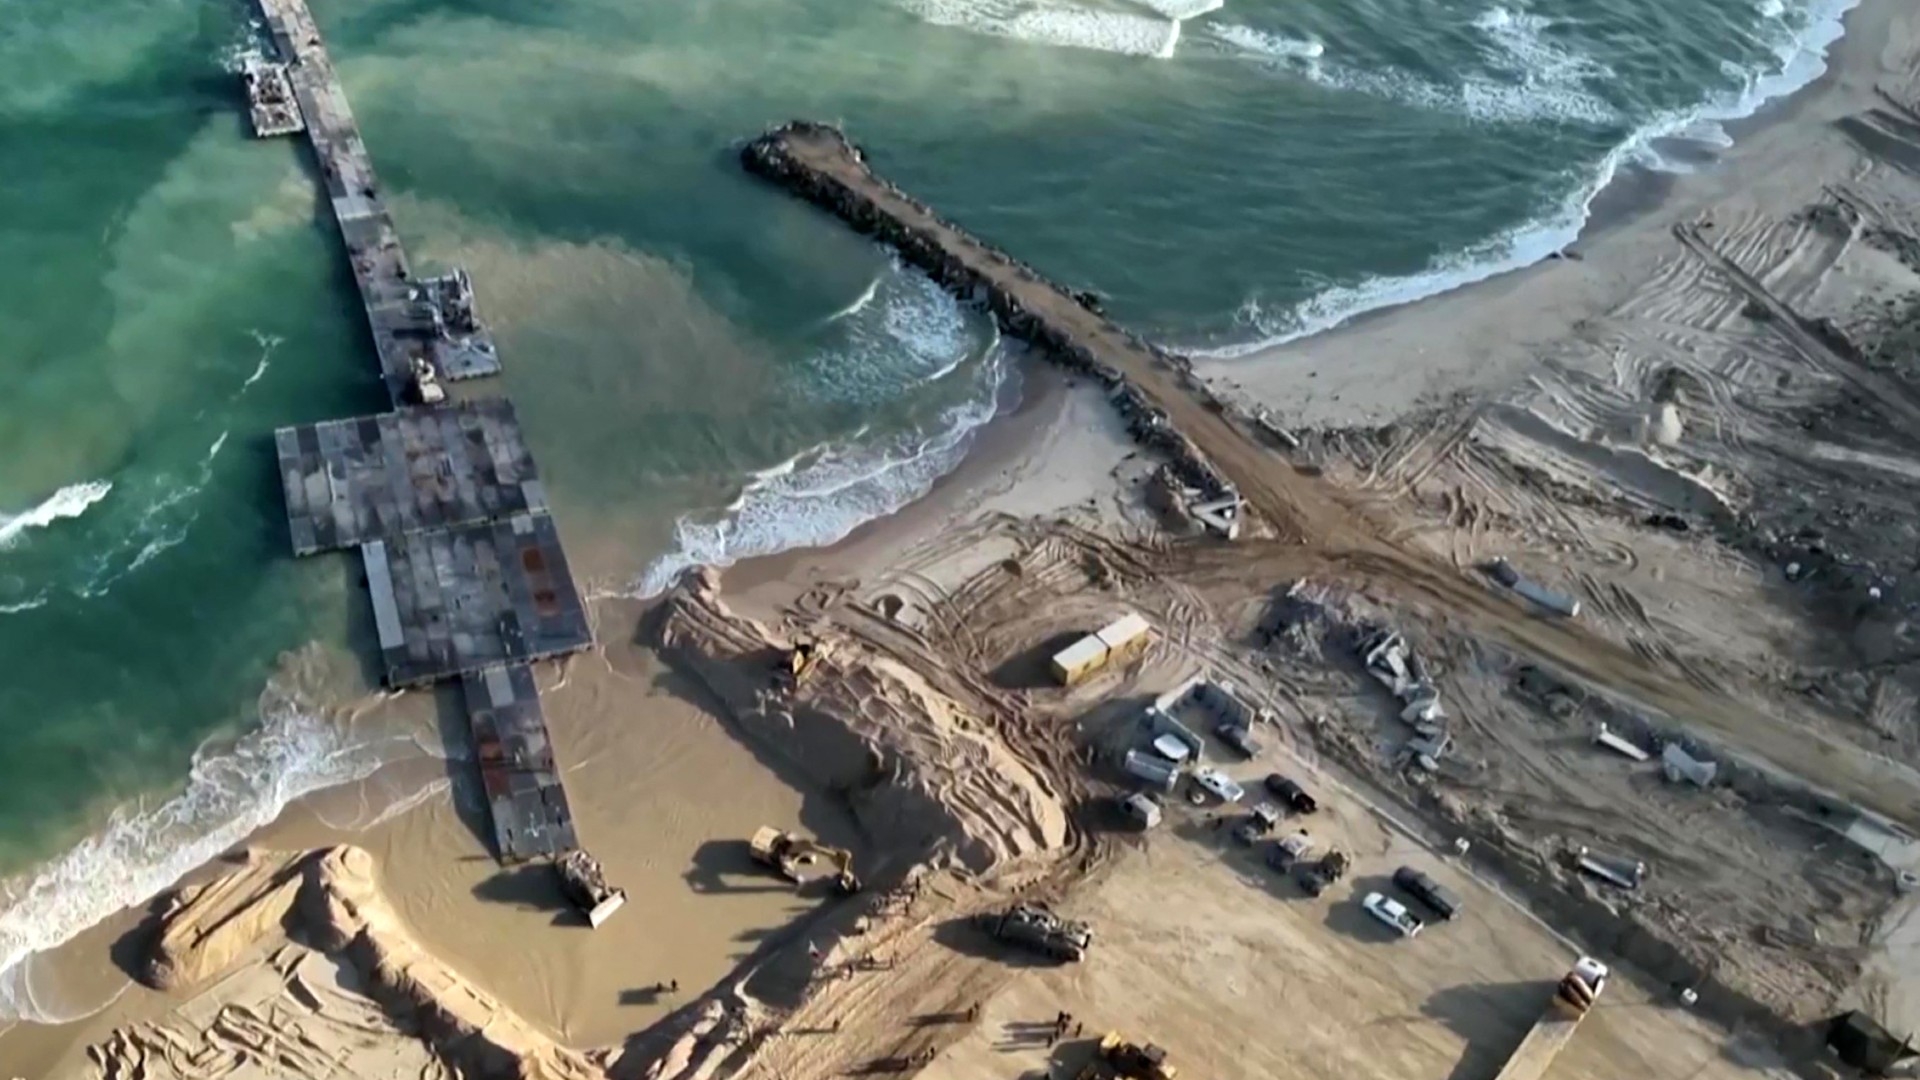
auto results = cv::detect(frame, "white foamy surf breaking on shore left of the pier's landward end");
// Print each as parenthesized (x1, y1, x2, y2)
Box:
(0, 682, 411, 1022)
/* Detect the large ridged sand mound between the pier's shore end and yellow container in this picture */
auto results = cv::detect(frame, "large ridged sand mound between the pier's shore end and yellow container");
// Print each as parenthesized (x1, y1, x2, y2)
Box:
(659, 573, 1068, 871)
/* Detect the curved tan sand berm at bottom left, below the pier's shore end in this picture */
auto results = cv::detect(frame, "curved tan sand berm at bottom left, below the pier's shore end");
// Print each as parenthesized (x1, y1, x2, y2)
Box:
(144, 847, 605, 1080)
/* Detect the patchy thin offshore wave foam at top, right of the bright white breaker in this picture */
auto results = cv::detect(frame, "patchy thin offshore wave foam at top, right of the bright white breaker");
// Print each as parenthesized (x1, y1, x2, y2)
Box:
(1208, 8, 1620, 125)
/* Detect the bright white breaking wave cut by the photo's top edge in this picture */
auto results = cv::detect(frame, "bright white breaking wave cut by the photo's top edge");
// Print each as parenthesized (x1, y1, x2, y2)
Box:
(902, 0, 1190, 60)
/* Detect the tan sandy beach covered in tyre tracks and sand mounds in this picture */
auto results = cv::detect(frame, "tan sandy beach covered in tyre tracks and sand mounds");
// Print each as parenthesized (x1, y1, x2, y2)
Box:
(11, 0, 1920, 1080)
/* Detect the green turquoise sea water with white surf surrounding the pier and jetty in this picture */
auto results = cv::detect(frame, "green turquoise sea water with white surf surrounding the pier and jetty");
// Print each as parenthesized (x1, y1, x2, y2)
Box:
(0, 0, 1849, 1022)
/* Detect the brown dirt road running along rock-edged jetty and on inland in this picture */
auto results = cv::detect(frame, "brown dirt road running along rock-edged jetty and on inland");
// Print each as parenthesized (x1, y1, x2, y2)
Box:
(749, 125, 1920, 830)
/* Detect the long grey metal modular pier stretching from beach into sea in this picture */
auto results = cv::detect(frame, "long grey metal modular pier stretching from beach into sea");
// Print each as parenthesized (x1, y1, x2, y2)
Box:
(246, 0, 593, 861)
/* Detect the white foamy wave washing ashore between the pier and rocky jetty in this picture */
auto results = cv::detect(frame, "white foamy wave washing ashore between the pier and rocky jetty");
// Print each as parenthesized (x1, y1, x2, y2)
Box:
(632, 346, 1010, 598)
